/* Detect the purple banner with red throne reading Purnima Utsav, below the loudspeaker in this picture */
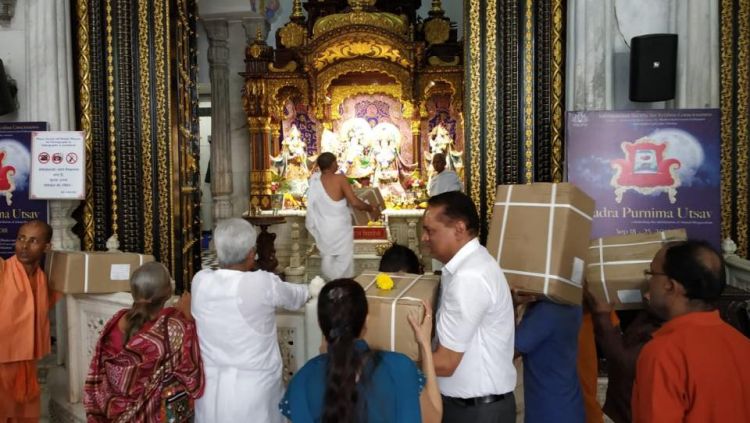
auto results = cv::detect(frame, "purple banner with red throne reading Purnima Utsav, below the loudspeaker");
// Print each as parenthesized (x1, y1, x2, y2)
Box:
(566, 109, 721, 248)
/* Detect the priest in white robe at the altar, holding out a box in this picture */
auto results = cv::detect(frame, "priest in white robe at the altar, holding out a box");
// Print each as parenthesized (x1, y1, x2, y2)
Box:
(305, 152, 377, 281)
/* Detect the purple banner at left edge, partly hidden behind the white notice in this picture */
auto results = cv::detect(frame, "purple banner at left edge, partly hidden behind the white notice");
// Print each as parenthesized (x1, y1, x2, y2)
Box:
(0, 132, 47, 258)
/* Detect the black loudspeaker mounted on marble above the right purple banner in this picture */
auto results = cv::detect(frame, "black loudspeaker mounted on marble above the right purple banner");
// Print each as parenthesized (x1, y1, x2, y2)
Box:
(630, 34, 677, 101)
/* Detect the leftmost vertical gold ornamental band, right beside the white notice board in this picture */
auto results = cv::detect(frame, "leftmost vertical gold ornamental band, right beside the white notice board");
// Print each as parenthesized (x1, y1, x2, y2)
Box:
(77, 0, 94, 251)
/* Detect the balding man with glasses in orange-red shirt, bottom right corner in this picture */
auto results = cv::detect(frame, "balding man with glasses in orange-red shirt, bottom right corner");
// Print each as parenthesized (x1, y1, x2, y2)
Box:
(632, 241, 750, 423)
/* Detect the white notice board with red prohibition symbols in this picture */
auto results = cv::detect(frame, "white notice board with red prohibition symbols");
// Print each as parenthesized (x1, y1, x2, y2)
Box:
(29, 131, 86, 200)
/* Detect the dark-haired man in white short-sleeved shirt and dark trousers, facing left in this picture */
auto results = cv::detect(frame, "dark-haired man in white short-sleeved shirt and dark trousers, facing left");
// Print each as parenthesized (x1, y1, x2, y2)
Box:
(422, 191, 516, 423)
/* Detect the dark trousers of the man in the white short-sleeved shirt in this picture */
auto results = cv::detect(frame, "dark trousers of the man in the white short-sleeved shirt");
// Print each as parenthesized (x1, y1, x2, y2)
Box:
(443, 392, 516, 423)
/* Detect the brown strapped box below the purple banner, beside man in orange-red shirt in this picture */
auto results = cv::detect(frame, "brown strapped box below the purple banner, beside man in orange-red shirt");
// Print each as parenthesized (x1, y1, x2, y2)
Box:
(586, 229, 687, 310)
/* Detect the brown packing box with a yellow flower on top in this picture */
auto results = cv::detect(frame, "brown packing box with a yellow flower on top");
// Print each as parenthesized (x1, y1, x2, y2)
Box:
(356, 272, 440, 361)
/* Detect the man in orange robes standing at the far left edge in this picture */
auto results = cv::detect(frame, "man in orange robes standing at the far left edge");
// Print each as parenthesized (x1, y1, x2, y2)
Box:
(0, 220, 52, 423)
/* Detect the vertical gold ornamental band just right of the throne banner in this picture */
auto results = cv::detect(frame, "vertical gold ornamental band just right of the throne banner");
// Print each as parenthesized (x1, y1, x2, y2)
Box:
(720, 0, 734, 247)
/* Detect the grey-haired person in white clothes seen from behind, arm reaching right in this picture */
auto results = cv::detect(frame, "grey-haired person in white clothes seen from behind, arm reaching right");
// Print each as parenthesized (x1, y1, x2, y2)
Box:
(191, 218, 309, 423)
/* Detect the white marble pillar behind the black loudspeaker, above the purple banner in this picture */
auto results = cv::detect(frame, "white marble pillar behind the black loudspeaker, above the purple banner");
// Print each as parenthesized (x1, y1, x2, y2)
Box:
(566, 0, 719, 110)
